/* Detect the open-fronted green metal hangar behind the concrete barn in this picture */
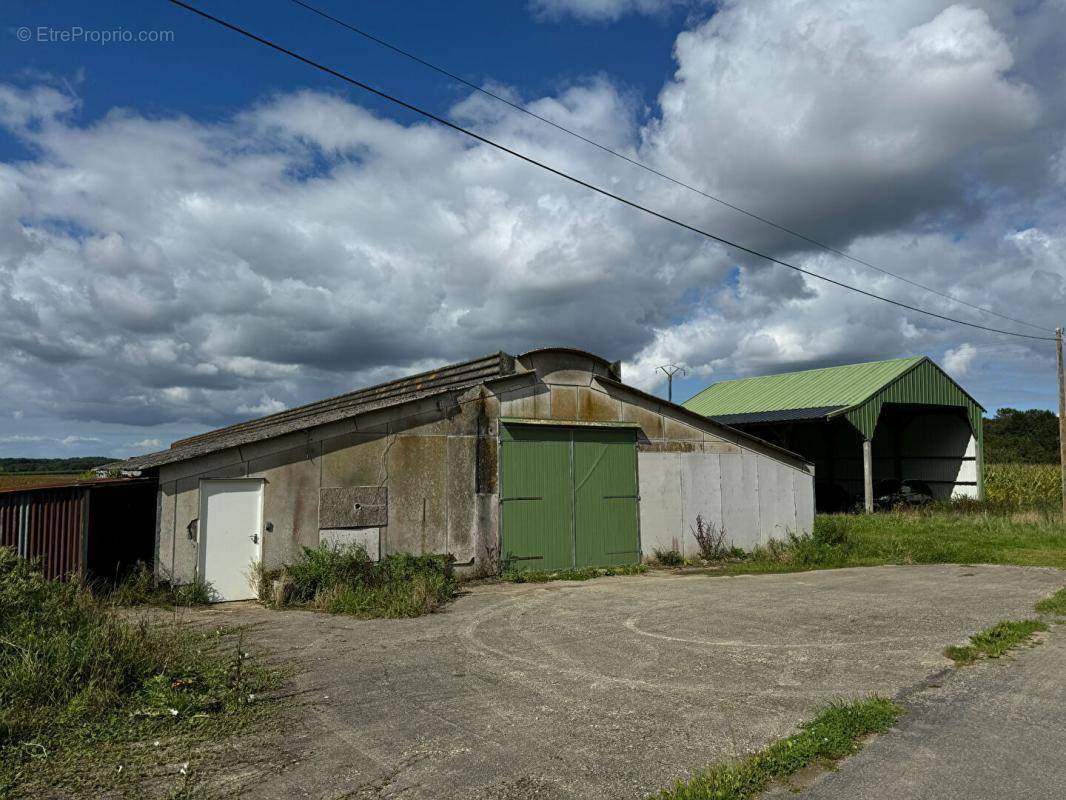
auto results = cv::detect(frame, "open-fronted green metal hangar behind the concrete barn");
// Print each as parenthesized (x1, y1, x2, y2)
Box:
(684, 356, 984, 511)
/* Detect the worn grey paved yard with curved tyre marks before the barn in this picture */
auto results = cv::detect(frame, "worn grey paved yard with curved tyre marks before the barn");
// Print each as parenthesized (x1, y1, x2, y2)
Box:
(187, 565, 1066, 800)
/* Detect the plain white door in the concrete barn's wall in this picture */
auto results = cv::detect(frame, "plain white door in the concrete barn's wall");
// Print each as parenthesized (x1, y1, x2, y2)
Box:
(199, 480, 263, 601)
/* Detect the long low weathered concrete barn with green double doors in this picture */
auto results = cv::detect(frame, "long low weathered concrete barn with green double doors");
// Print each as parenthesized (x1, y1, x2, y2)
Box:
(113, 349, 814, 599)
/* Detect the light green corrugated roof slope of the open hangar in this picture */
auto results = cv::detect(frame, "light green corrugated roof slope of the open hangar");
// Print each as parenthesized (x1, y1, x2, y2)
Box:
(682, 355, 925, 418)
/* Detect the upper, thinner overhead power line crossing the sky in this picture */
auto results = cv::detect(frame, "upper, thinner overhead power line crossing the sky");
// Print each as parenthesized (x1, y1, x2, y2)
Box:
(289, 0, 1051, 333)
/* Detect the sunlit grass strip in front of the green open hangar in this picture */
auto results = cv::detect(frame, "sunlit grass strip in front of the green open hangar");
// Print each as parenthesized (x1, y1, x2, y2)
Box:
(712, 503, 1066, 575)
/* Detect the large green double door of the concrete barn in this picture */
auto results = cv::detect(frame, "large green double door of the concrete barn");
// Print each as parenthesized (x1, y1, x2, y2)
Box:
(500, 425, 641, 570)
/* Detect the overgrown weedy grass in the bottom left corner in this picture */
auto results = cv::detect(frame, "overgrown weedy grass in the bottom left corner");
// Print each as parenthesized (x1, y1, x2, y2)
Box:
(0, 548, 276, 797)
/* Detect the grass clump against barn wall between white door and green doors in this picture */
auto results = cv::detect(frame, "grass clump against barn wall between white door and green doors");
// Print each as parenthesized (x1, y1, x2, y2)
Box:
(268, 545, 458, 619)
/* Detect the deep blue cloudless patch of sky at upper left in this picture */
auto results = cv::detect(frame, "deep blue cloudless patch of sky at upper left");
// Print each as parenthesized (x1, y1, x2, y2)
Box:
(0, 0, 688, 157)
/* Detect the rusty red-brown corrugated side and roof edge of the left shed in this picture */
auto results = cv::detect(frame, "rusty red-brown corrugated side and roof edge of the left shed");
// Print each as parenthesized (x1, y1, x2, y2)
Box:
(0, 479, 155, 579)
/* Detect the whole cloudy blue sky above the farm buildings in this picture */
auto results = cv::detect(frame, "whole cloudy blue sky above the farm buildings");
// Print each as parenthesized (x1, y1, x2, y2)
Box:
(0, 0, 1066, 455)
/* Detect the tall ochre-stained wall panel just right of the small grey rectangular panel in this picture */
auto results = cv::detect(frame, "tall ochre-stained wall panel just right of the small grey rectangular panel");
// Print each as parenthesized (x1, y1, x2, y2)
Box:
(382, 436, 448, 554)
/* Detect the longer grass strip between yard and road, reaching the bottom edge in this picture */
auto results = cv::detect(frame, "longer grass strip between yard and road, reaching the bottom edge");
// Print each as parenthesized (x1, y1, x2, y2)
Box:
(649, 698, 903, 800)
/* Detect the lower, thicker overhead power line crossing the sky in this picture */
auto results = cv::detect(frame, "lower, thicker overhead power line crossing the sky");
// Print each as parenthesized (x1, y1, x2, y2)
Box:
(168, 0, 1054, 341)
